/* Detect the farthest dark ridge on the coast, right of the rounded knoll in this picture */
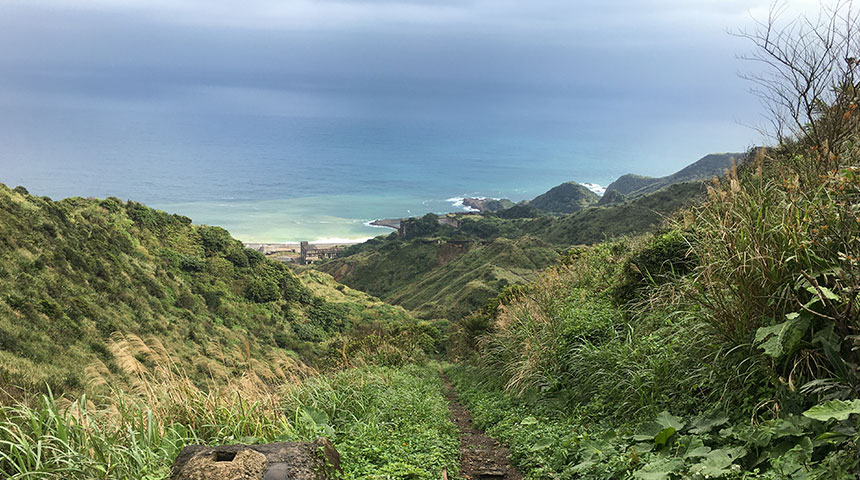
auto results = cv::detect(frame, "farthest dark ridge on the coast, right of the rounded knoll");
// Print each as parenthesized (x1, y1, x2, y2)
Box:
(603, 153, 745, 200)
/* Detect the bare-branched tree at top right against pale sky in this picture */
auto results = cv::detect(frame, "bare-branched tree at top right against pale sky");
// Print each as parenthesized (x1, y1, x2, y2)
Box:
(734, 0, 860, 152)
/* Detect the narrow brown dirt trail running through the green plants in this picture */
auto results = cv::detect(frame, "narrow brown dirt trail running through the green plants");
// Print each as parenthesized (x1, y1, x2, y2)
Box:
(442, 375, 523, 480)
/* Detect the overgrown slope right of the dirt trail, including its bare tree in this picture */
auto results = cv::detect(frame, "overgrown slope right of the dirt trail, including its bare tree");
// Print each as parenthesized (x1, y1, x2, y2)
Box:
(449, 3, 860, 479)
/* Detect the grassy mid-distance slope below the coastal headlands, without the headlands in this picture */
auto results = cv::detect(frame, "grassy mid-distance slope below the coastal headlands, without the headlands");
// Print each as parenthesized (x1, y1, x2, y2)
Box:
(315, 183, 704, 320)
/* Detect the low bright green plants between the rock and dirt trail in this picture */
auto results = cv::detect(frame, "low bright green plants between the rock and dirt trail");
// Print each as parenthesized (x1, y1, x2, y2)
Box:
(284, 364, 459, 480)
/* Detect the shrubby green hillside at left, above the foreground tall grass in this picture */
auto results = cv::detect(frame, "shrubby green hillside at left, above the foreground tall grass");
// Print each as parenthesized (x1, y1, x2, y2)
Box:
(0, 185, 426, 396)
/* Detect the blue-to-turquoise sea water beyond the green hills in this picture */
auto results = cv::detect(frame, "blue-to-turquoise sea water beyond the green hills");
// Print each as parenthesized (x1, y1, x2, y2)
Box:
(0, 106, 754, 242)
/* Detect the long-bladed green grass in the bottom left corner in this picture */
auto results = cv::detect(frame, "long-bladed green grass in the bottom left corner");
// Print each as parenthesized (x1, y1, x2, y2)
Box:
(0, 395, 201, 479)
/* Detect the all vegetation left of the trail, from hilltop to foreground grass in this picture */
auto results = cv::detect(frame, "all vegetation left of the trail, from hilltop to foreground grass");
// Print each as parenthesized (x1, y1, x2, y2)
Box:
(0, 185, 456, 479)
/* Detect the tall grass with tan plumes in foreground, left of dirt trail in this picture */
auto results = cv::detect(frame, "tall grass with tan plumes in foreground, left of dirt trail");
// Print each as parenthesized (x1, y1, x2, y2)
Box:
(0, 334, 457, 479)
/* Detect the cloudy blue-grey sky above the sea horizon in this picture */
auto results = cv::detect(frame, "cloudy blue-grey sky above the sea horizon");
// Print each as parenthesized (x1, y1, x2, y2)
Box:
(0, 0, 816, 122)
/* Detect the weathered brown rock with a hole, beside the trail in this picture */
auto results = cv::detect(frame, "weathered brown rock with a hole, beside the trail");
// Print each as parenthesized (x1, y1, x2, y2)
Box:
(170, 438, 342, 480)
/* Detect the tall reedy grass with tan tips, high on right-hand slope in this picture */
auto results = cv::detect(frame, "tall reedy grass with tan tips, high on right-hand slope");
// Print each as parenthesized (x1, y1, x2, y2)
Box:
(685, 149, 860, 396)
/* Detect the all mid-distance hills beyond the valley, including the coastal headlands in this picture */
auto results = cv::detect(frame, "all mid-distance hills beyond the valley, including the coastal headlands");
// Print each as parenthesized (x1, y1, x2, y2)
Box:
(320, 150, 742, 320)
